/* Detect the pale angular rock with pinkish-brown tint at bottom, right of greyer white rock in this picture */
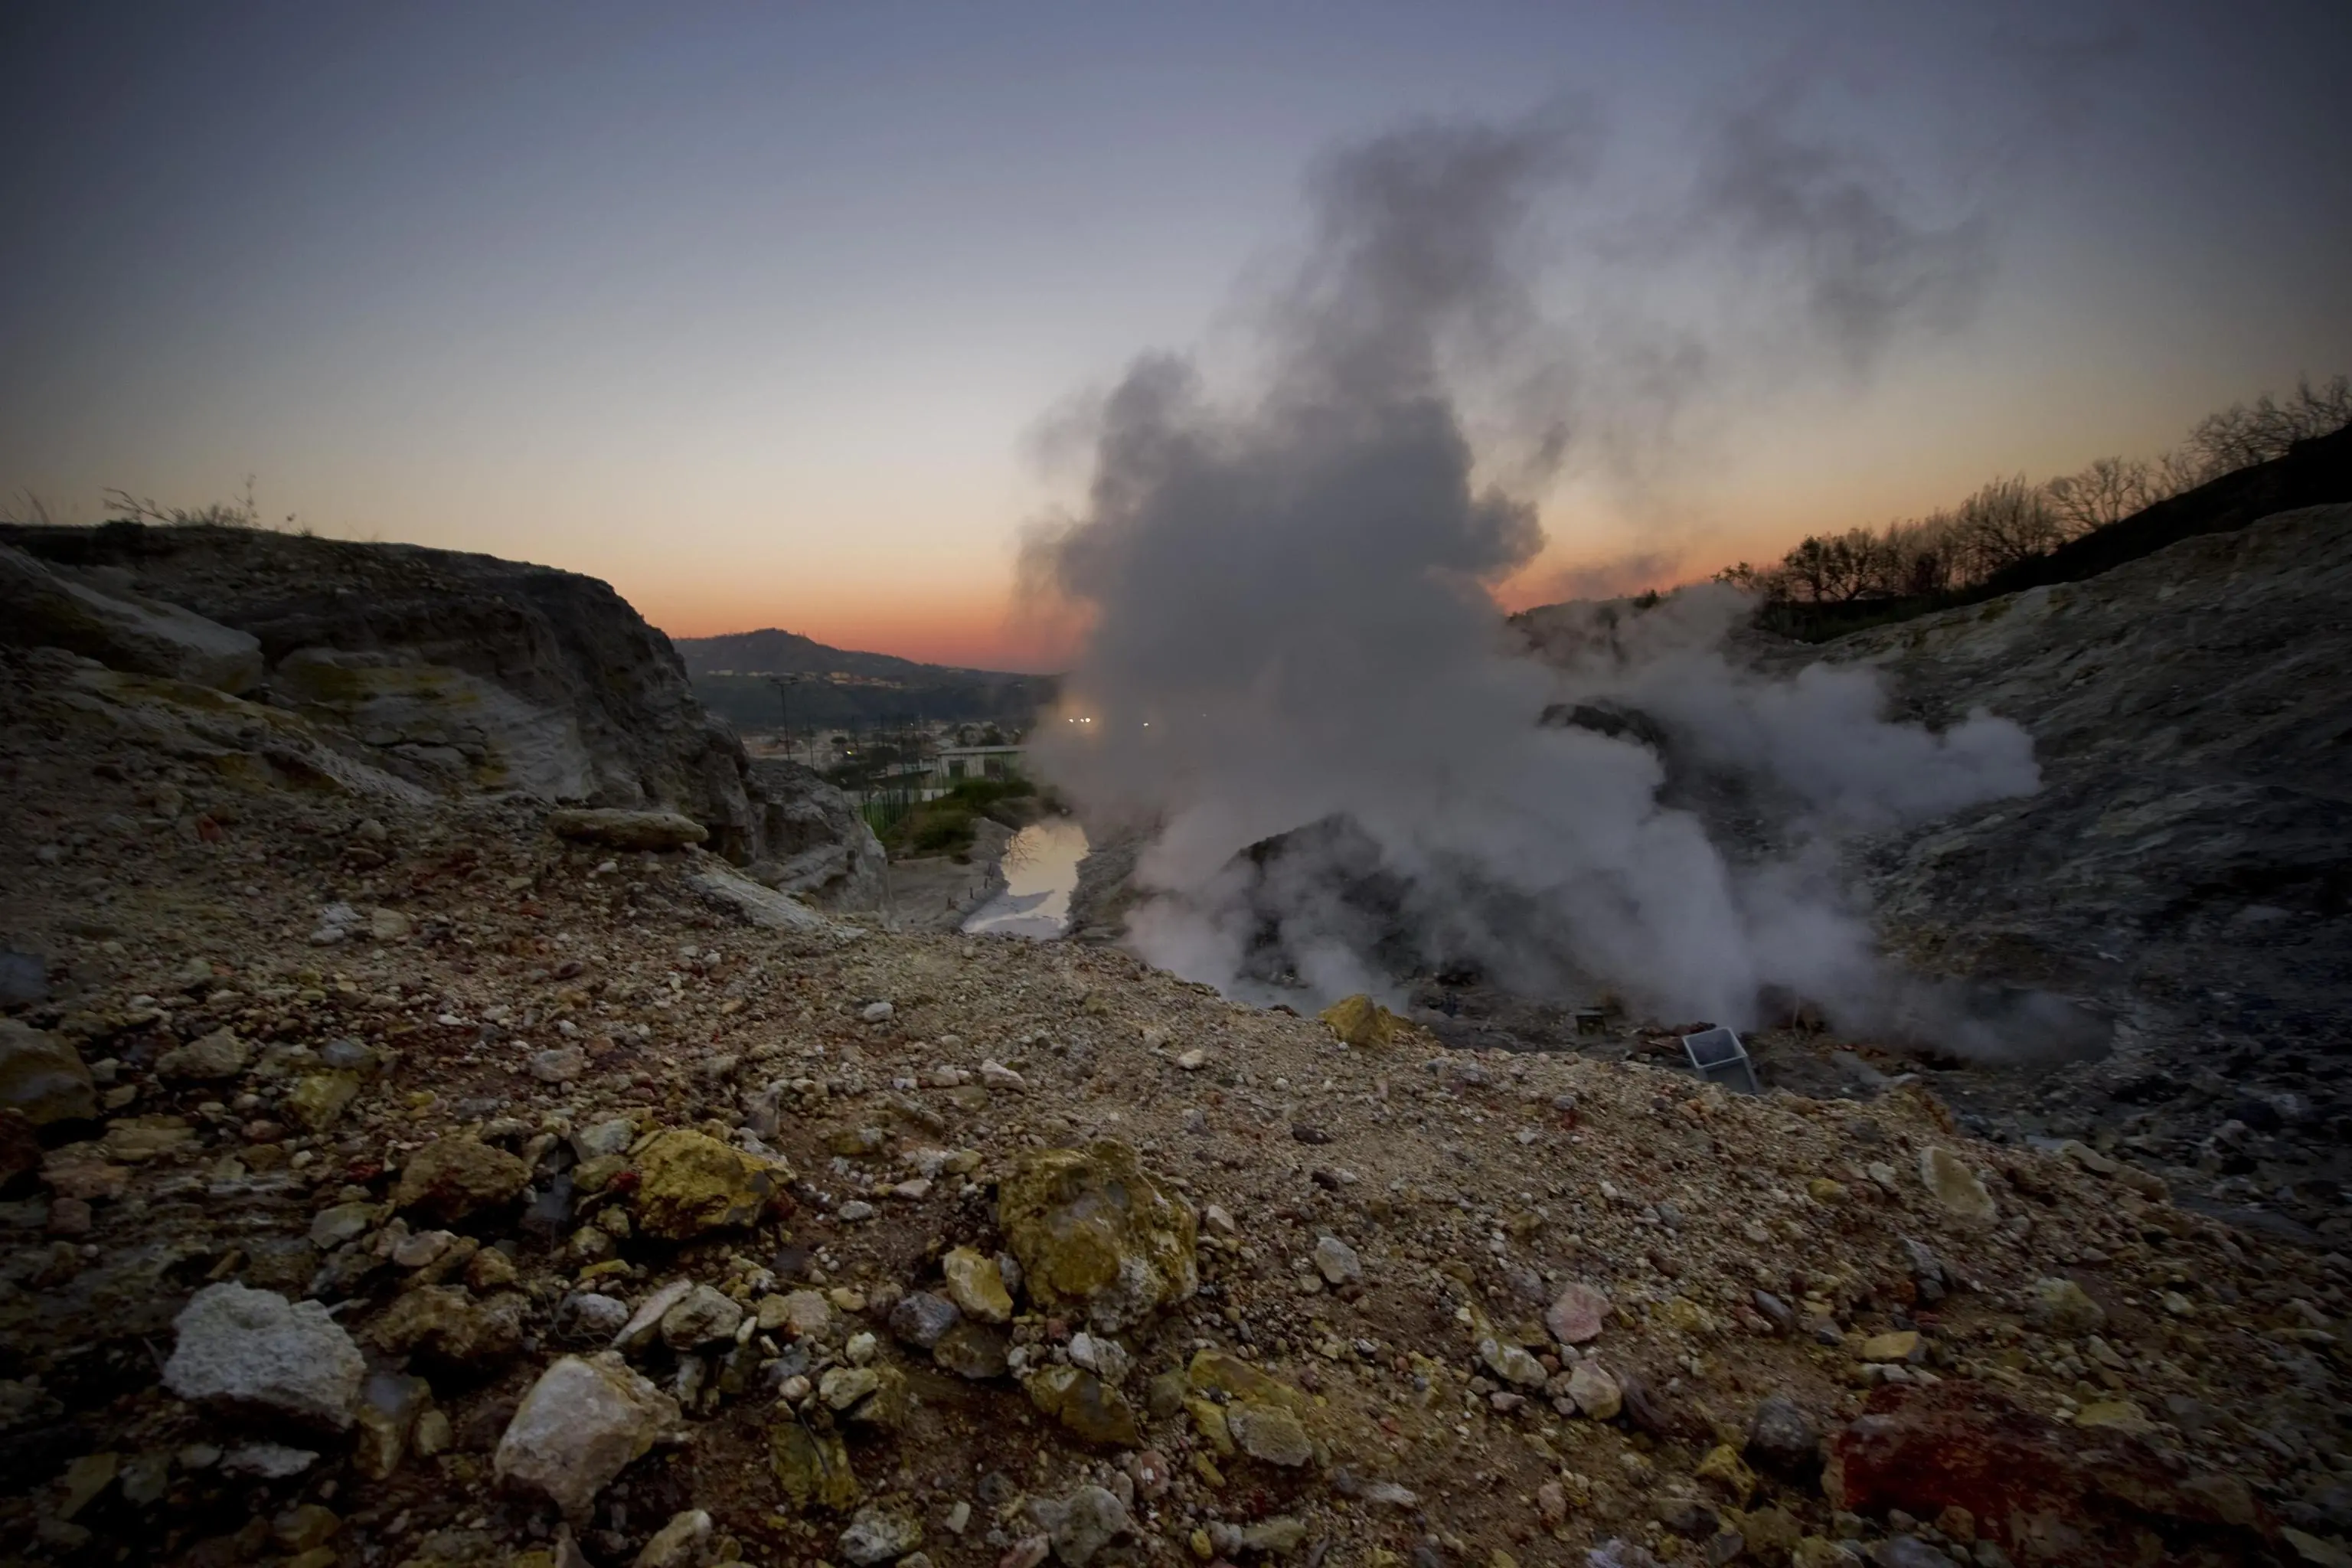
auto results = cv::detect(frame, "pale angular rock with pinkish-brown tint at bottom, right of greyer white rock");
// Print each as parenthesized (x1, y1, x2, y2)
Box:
(492, 1352, 678, 1521)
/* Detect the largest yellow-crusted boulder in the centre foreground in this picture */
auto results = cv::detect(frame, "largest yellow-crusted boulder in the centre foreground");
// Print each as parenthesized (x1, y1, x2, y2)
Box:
(998, 1140, 1200, 1333)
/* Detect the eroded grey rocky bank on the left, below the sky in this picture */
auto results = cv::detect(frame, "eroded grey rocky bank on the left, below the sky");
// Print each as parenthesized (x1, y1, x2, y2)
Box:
(0, 522, 882, 907)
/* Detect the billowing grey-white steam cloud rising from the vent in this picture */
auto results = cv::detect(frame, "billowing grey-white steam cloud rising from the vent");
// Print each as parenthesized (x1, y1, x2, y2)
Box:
(1025, 113, 2037, 1044)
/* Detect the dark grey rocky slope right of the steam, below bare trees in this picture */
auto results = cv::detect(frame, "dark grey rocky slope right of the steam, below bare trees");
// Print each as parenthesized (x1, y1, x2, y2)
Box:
(1775, 505, 2352, 1241)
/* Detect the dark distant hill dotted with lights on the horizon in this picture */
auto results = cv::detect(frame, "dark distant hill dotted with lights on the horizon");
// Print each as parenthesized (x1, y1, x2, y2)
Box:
(671, 628, 1054, 729)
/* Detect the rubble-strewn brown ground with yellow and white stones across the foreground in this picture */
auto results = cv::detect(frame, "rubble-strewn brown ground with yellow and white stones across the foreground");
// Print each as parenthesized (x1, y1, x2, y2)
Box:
(0, 652, 2352, 1568)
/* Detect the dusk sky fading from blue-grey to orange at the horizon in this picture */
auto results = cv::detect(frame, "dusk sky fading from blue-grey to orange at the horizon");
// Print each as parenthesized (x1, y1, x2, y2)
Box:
(0, 0, 2352, 668)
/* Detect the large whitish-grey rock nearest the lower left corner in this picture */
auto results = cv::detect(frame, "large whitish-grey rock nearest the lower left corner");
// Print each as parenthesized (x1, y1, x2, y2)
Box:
(162, 1281, 367, 1432)
